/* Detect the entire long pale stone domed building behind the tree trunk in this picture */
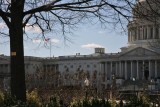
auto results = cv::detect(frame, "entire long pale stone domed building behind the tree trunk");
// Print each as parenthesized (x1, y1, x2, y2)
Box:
(0, 0, 160, 90)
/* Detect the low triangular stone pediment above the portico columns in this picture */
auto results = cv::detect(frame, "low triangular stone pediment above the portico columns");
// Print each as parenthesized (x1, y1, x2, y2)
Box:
(120, 47, 160, 56)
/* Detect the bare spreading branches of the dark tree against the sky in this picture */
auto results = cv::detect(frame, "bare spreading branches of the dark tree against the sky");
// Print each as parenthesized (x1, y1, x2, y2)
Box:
(0, 0, 133, 37)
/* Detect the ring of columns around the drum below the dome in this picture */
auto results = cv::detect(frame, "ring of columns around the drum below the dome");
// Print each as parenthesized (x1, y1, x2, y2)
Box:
(128, 26, 160, 42)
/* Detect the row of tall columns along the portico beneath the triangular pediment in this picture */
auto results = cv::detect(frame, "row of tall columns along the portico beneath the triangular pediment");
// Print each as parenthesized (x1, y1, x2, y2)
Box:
(101, 60, 160, 80)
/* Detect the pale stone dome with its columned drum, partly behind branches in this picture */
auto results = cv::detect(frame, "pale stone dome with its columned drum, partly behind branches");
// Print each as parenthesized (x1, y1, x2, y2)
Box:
(128, 0, 160, 47)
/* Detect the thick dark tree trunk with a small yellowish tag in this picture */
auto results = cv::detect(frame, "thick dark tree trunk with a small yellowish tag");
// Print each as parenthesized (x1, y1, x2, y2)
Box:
(9, 0, 26, 101)
